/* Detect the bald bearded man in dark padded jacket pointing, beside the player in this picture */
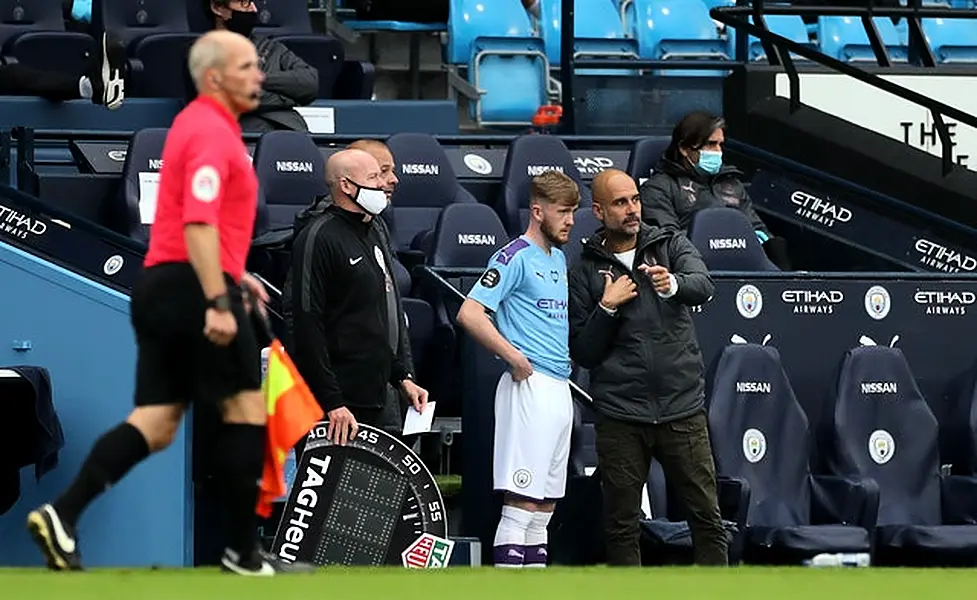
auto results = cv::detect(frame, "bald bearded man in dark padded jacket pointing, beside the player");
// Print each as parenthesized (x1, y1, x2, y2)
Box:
(569, 169, 727, 566)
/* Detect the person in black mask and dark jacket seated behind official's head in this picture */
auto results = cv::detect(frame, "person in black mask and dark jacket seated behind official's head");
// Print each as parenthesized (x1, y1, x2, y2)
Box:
(203, 0, 319, 132)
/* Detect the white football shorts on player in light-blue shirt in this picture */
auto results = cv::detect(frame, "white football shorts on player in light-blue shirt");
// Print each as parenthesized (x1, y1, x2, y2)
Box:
(492, 371, 573, 500)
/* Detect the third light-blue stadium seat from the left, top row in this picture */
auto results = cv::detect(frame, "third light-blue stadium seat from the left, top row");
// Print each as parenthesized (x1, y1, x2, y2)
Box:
(626, 0, 729, 77)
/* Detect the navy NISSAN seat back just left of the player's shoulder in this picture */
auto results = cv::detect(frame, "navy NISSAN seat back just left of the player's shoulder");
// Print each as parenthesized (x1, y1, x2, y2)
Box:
(428, 203, 509, 268)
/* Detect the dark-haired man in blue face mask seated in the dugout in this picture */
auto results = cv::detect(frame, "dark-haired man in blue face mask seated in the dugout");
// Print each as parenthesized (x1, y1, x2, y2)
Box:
(641, 112, 790, 270)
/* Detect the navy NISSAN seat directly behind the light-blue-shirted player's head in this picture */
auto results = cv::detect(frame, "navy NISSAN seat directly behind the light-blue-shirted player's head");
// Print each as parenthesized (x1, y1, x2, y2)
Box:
(497, 135, 591, 235)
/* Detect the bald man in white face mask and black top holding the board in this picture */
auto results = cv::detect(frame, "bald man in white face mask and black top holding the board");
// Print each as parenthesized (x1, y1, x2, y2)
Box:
(286, 149, 428, 445)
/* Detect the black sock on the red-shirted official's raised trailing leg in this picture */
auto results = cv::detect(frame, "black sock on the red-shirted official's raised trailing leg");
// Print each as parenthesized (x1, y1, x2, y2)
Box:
(53, 423, 149, 527)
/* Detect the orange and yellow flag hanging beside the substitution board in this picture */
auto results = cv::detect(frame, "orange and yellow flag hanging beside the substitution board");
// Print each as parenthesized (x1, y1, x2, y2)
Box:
(257, 340, 325, 518)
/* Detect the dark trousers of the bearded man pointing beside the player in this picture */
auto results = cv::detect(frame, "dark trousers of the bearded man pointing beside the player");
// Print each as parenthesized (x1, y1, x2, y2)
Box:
(595, 412, 728, 566)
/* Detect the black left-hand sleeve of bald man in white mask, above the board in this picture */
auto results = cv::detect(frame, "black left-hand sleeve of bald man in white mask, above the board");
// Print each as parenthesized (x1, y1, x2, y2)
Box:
(291, 228, 344, 412)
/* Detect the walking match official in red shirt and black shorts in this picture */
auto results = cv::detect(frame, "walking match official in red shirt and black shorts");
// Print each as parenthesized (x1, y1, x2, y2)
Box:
(27, 31, 307, 575)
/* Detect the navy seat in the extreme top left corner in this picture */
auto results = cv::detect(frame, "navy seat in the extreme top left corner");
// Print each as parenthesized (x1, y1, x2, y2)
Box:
(0, 0, 96, 76)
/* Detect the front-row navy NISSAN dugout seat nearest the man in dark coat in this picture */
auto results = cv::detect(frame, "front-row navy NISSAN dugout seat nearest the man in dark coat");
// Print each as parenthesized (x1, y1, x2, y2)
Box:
(709, 344, 879, 564)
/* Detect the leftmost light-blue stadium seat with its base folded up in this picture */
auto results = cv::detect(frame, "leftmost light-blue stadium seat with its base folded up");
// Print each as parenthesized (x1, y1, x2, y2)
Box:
(445, 0, 549, 126)
